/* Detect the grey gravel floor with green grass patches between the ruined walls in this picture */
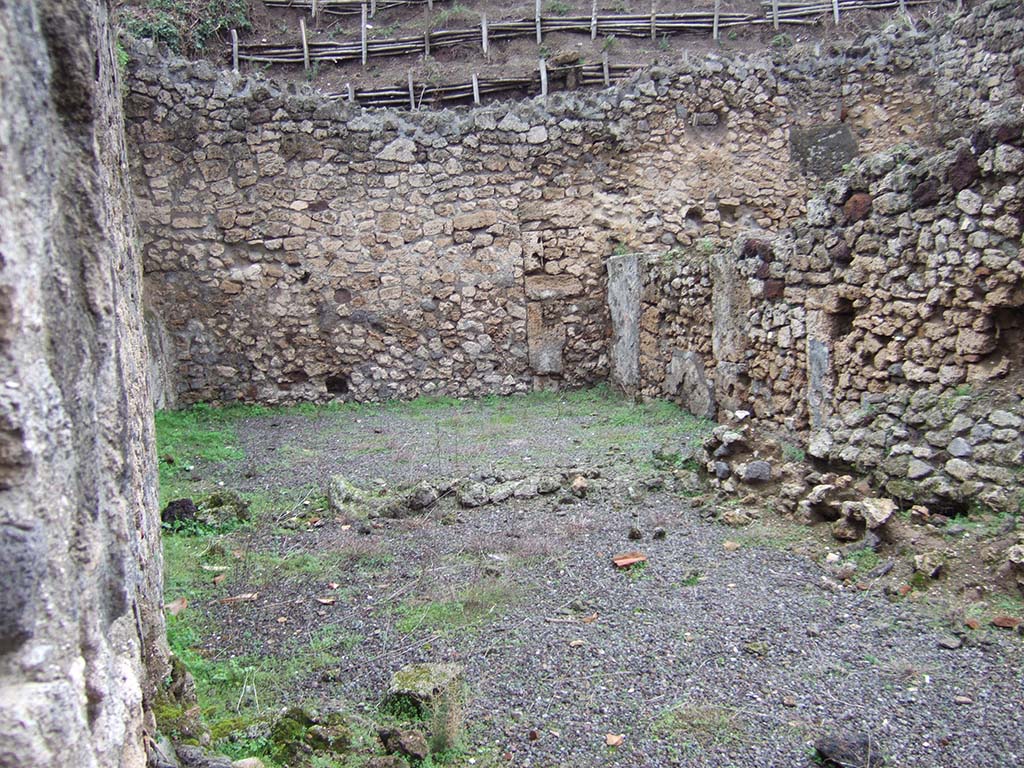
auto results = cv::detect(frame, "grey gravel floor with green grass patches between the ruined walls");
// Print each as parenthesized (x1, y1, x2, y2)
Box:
(161, 391, 1024, 768)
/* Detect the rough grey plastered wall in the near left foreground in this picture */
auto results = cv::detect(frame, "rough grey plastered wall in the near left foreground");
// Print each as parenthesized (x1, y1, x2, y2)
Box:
(0, 0, 164, 768)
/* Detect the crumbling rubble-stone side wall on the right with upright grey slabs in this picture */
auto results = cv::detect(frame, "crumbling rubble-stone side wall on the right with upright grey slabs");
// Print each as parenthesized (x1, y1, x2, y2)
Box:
(638, 0, 1024, 510)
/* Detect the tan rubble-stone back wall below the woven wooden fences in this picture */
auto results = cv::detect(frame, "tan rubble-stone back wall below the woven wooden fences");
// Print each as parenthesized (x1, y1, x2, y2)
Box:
(128, 1, 954, 403)
